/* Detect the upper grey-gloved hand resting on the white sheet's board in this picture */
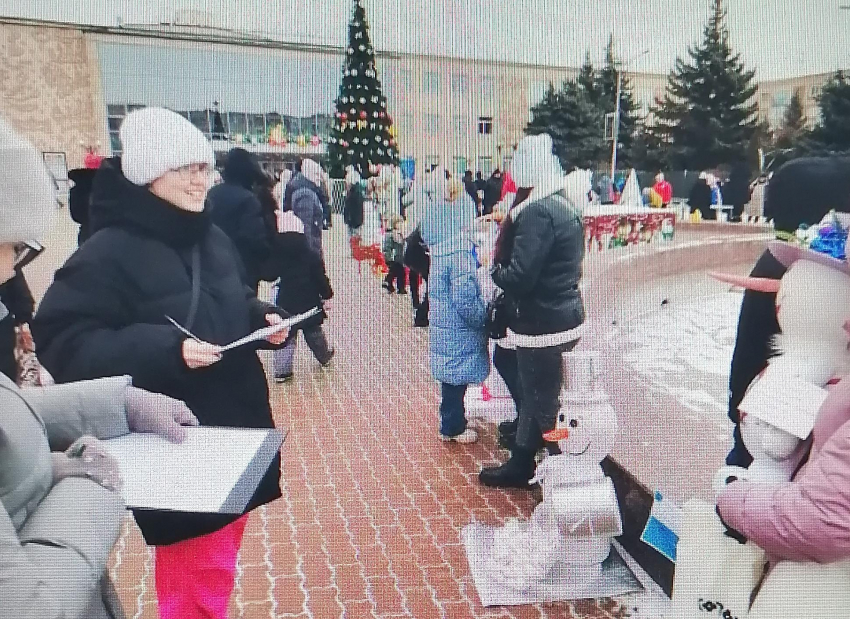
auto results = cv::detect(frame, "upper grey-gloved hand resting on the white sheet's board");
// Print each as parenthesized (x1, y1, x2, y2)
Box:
(124, 386, 198, 443)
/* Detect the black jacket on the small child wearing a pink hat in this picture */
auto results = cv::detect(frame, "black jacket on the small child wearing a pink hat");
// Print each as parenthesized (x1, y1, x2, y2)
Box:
(272, 232, 334, 328)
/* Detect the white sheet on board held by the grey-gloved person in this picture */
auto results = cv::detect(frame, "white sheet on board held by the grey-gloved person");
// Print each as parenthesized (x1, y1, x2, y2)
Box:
(104, 427, 283, 513)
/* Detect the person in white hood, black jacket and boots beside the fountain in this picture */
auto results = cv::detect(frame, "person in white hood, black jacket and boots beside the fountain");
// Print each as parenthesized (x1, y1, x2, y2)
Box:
(479, 134, 585, 489)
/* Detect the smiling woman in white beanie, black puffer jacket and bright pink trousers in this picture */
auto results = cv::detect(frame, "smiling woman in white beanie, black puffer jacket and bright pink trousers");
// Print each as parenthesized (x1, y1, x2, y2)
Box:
(33, 108, 286, 619)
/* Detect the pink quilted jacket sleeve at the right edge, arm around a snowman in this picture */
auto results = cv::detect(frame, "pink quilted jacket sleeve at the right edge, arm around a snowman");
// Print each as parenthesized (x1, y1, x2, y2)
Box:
(717, 377, 850, 563)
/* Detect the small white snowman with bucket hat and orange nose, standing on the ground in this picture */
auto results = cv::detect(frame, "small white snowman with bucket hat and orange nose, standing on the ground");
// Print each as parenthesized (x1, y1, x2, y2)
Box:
(486, 352, 622, 591)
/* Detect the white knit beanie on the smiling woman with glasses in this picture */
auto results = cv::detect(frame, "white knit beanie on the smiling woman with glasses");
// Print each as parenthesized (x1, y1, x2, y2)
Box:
(120, 107, 215, 185)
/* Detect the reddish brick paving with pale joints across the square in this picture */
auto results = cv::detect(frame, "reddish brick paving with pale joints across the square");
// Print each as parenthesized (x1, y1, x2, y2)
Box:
(112, 220, 660, 619)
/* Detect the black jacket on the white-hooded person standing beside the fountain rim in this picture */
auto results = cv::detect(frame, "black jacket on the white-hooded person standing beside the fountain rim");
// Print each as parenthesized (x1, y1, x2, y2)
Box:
(493, 194, 584, 335)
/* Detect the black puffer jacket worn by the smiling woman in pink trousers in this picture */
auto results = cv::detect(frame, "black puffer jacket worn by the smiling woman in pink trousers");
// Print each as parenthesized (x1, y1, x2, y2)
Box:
(32, 159, 280, 544)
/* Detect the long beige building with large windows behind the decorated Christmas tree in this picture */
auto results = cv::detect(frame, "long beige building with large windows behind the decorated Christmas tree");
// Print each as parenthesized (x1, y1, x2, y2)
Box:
(0, 19, 829, 175)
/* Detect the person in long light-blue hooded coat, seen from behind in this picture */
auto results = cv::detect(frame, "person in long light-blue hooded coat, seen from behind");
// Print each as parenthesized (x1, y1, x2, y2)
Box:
(422, 180, 490, 443)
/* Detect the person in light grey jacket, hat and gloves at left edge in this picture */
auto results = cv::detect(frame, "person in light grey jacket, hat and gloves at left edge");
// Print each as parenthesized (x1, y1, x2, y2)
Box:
(0, 119, 197, 619)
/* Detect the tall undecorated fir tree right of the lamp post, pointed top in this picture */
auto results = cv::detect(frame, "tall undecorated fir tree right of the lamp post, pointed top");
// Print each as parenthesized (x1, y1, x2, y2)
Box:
(652, 0, 758, 170)
